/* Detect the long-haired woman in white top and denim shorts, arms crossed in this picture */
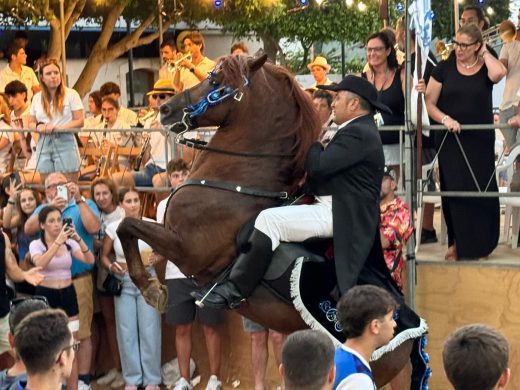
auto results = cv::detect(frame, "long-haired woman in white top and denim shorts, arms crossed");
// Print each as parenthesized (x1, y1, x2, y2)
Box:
(29, 59, 84, 181)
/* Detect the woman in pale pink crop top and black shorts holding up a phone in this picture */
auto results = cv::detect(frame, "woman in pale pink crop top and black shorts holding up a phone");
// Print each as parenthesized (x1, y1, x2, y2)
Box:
(29, 206, 94, 388)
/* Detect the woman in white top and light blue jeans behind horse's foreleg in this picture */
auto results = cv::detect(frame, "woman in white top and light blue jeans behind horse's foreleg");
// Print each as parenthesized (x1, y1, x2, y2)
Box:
(101, 188, 161, 390)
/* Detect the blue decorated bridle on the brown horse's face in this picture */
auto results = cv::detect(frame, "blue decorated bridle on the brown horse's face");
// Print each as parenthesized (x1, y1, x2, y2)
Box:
(184, 65, 249, 119)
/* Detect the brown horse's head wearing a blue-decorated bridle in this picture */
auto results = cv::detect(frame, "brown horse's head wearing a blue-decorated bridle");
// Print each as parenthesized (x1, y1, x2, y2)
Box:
(160, 55, 267, 132)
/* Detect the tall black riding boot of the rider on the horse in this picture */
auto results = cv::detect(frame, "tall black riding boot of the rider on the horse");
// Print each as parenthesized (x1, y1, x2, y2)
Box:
(191, 229, 273, 309)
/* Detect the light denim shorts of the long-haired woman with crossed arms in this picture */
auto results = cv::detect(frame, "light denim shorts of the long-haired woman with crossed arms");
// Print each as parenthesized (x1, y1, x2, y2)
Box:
(36, 133, 79, 173)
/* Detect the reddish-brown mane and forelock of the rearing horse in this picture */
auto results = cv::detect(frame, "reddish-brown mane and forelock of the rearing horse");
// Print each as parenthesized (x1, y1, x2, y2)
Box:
(216, 55, 321, 176)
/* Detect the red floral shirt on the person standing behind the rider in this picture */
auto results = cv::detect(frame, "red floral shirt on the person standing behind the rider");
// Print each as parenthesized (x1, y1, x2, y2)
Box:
(379, 197, 413, 289)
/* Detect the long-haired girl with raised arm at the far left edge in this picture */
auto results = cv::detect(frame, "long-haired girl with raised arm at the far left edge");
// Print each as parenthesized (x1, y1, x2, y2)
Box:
(3, 179, 41, 295)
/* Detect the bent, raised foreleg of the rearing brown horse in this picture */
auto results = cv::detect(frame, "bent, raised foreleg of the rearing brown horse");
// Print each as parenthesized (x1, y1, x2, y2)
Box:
(117, 218, 172, 312)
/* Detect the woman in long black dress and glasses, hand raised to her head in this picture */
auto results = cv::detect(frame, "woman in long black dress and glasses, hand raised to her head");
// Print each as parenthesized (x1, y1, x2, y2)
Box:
(426, 24, 506, 260)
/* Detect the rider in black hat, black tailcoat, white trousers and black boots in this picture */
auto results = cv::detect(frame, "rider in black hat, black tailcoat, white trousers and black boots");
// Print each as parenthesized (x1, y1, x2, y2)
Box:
(191, 75, 406, 308)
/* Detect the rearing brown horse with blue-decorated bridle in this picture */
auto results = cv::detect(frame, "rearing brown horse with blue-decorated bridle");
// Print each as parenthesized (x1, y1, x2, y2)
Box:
(118, 56, 426, 385)
